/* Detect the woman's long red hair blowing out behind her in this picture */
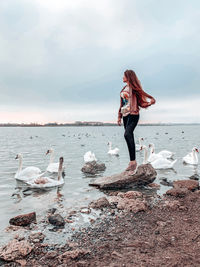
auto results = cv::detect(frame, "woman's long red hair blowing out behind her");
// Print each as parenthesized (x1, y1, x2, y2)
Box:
(124, 70, 155, 108)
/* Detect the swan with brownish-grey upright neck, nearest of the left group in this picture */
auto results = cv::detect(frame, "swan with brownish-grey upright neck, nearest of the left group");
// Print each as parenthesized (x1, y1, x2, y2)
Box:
(26, 157, 64, 189)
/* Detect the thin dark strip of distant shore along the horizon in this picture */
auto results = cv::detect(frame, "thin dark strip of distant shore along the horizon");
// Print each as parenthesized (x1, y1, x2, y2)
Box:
(0, 122, 200, 127)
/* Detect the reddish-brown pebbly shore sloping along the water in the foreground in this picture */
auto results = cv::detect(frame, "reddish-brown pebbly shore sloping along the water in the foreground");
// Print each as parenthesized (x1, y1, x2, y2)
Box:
(0, 180, 200, 267)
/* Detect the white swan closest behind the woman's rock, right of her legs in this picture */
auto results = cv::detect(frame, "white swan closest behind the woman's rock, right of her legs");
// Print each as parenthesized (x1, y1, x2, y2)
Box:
(141, 145, 177, 169)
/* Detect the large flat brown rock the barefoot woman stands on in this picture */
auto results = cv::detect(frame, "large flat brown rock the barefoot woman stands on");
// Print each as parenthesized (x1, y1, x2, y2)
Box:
(89, 164, 157, 189)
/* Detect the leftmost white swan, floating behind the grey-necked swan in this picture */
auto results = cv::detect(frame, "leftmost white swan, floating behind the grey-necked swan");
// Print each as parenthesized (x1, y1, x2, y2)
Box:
(15, 154, 41, 182)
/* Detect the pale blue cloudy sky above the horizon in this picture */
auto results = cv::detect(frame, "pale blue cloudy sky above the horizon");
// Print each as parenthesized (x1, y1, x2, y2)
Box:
(0, 0, 200, 123)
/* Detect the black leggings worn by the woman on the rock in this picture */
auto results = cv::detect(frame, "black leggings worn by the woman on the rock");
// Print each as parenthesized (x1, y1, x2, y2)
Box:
(123, 114, 139, 160)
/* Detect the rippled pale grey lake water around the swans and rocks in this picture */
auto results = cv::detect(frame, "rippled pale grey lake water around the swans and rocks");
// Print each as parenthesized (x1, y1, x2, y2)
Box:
(0, 125, 200, 246)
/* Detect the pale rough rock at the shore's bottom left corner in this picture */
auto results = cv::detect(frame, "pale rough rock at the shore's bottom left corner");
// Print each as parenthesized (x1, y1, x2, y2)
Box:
(0, 239, 33, 261)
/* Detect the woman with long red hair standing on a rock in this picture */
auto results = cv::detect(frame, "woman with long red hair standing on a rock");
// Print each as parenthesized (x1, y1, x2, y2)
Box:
(118, 70, 156, 174)
